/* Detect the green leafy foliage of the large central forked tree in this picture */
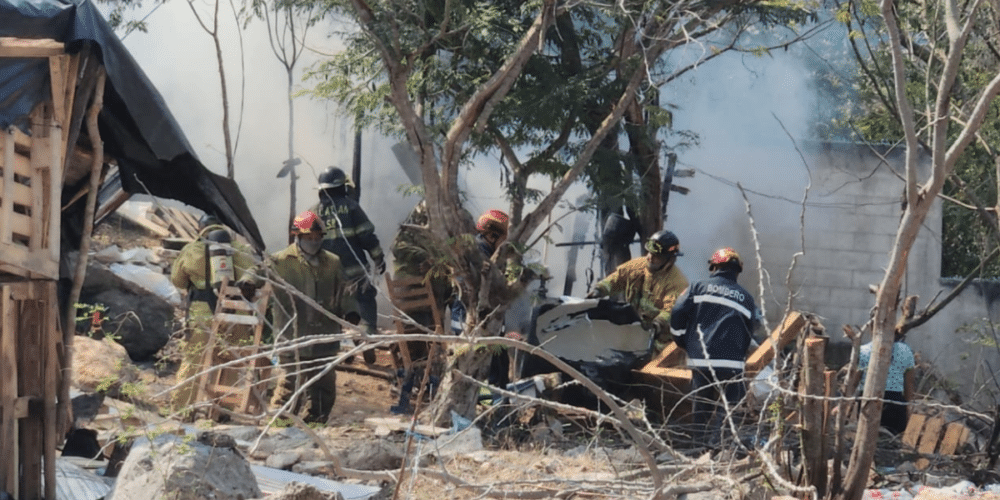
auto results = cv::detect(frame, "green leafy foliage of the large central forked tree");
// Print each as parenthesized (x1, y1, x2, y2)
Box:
(306, 0, 816, 227)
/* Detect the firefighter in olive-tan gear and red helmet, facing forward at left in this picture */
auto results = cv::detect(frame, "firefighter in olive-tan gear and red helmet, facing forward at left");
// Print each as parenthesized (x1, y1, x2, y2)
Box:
(240, 211, 355, 423)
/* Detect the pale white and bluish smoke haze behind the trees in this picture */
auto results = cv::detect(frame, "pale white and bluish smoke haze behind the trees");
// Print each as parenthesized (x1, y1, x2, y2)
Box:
(124, 0, 828, 295)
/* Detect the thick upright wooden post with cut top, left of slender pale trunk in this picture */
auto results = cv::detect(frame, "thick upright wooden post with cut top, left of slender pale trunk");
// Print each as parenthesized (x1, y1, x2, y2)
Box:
(799, 337, 827, 498)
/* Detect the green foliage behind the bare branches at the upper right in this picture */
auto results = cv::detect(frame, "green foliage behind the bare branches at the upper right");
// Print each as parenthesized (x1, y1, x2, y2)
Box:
(835, 0, 1000, 277)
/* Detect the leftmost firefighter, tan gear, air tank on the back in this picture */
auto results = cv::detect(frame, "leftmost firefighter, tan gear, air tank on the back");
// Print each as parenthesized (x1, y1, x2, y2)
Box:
(170, 221, 253, 418)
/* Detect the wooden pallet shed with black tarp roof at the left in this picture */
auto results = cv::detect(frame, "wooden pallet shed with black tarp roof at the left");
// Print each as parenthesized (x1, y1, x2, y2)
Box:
(0, 0, 263, 500)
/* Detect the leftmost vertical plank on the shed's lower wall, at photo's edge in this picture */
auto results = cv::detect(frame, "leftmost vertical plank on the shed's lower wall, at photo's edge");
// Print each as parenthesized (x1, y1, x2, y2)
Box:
(0, 286, 18, 498)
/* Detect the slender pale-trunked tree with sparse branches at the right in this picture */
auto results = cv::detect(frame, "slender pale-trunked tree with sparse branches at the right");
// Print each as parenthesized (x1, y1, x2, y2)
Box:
(834, 0, 1000, 500)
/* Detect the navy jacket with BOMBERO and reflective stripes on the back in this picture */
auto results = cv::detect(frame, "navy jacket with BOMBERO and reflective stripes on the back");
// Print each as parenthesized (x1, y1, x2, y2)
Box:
(670, 270, 758, 369)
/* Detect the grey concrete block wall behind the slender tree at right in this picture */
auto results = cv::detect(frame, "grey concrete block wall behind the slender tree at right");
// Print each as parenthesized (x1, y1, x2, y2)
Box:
(742, 143, 1000, 403)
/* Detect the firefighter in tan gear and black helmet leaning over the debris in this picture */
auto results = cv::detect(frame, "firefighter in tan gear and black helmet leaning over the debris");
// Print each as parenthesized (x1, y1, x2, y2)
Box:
(587, 230, 688, 356)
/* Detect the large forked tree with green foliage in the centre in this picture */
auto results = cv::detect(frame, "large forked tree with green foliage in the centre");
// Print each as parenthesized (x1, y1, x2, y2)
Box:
(311, 0, 820, 430)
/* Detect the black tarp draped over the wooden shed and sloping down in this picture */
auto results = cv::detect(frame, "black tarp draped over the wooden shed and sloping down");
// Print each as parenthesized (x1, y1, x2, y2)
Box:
(0, 0, 263, 249)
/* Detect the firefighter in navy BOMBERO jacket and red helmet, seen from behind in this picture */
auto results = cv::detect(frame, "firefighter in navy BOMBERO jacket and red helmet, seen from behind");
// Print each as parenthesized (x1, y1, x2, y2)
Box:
(670, 248, 760, 446)
